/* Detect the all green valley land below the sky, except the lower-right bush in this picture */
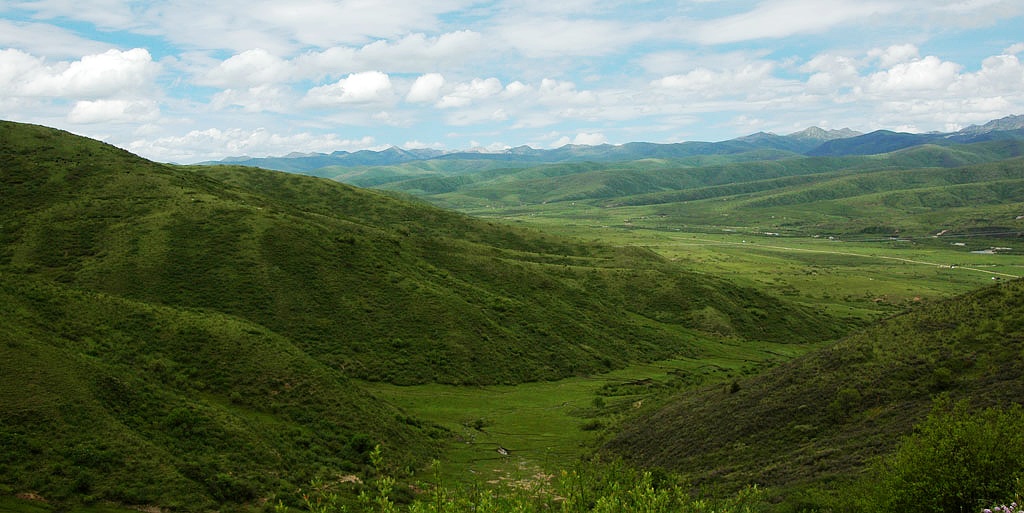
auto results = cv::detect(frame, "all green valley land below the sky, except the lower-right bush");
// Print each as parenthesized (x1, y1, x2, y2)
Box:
(6, 116, 1024, 513)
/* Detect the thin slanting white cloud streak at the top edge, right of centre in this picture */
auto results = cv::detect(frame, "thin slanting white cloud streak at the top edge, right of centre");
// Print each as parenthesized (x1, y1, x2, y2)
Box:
(692, 0, 900, 45)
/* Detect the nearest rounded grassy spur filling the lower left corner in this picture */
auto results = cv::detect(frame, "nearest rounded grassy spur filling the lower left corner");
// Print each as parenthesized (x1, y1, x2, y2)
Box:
(0, 272, 436, 510)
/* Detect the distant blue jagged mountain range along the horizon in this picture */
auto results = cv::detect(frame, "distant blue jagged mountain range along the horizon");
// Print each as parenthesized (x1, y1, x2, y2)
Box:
(202, 116, 1024, 173)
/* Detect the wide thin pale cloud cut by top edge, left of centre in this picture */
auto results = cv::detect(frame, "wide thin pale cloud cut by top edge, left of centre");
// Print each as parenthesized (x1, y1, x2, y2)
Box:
(81, 0, 473, 54)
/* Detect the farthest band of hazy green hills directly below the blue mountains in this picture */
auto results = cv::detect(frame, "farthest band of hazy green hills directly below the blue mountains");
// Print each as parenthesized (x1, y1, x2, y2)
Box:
(380, 140, 1024, 207)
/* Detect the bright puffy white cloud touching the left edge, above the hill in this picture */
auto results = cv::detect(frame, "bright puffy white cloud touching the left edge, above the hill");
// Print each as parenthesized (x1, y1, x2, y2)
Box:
(0, 48, 160, 99)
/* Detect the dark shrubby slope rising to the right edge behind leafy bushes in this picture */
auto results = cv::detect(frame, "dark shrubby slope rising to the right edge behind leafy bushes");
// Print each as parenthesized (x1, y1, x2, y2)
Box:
(608, 281, 1024, 495)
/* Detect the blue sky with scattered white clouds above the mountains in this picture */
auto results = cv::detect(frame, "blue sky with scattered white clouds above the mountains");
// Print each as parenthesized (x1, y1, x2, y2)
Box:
(0, 0, 1024, 163)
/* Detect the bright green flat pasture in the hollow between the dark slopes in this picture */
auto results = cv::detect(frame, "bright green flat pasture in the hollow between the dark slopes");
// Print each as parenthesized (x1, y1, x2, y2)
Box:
(360, 339, 813, 484)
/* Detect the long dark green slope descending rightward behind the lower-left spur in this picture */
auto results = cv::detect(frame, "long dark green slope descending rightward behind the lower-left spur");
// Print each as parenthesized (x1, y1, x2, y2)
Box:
(0, 118, 843, 383)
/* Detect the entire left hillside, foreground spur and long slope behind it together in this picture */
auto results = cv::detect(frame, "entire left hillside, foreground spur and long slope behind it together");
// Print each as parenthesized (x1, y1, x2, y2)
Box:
(0, 122, 852, 510)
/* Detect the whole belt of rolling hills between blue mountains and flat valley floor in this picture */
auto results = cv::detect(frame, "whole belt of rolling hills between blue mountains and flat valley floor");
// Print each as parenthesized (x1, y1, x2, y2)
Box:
(397, 139, 1024, 246)
